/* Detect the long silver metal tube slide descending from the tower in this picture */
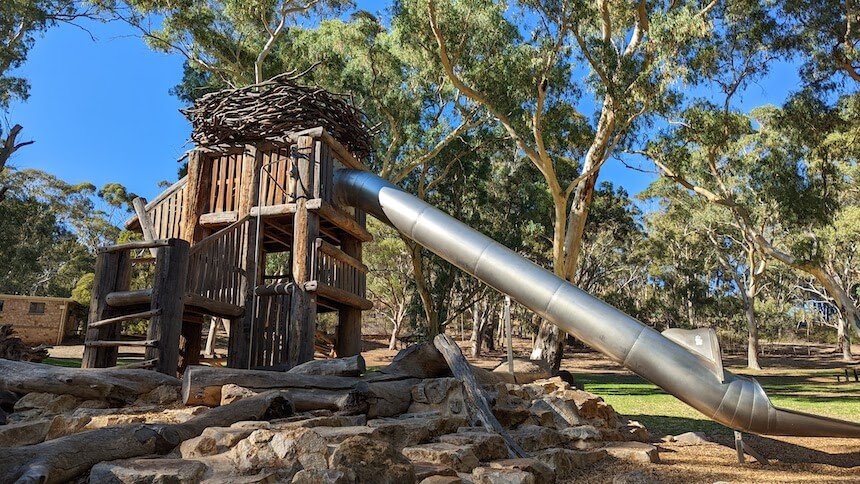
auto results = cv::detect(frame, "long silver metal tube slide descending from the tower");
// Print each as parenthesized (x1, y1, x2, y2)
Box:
(335, 170, 860, 438)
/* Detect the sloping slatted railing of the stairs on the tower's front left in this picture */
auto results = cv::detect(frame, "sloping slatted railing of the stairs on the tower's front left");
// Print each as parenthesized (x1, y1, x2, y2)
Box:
(187, 217, 249, 306)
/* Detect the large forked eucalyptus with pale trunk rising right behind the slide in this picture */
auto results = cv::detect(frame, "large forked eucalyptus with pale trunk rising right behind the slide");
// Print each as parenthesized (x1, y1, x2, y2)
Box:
(394, 0, 716, 368)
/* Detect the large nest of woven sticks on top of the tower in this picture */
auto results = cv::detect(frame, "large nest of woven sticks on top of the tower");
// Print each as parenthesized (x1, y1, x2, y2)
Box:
(182, 73, 371, 159)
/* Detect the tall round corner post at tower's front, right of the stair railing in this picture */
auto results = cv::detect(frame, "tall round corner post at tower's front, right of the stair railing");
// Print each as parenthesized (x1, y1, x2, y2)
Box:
(287, 136, 319, 367)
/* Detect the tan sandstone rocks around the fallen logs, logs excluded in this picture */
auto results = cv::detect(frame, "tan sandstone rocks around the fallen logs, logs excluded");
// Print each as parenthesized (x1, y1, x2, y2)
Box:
(0, 346, 664, 483)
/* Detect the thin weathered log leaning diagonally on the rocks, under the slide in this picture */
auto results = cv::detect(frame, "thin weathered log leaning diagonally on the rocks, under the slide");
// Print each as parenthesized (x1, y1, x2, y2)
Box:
(433, 334, 528, 458)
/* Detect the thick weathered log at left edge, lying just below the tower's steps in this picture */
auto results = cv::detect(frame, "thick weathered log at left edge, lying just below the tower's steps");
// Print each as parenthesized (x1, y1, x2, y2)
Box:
(0, 359, 180, 402)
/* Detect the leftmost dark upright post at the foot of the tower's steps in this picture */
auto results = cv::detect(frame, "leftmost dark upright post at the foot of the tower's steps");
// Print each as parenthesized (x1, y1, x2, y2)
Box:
(81, 250, 131, 368)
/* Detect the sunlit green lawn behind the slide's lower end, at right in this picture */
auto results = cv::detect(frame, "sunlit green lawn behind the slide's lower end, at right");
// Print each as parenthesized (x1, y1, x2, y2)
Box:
(574, 370, 860, 437)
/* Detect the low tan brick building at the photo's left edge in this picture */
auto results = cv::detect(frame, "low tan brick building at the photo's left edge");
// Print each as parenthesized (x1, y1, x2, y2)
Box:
(0, 294, 77, 345)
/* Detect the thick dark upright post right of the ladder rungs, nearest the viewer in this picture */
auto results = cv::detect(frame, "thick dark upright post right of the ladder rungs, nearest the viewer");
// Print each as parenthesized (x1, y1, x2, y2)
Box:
(145, 239, 189, 375)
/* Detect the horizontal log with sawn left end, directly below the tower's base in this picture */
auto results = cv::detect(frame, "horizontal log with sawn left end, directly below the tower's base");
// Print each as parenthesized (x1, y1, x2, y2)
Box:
(182, 366, 370, 415)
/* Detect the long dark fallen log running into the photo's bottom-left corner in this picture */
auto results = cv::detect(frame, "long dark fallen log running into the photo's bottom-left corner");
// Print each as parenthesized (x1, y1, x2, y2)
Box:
(0, 390, 293, 484)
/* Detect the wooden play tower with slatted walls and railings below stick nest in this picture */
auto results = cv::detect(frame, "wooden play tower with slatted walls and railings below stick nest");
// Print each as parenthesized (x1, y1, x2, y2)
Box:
(84, 79, 372, 373)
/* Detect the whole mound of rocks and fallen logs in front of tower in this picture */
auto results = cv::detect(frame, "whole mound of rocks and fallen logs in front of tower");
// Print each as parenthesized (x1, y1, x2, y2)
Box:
(0, 342, 657, 483)
